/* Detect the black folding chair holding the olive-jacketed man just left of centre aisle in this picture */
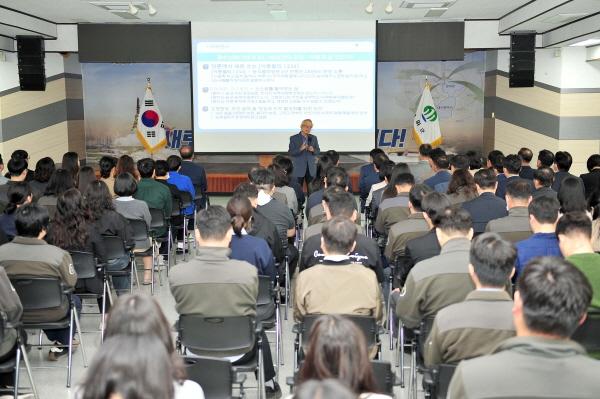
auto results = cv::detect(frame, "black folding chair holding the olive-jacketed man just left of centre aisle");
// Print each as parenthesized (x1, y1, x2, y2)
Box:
(177, 315, 266, 399)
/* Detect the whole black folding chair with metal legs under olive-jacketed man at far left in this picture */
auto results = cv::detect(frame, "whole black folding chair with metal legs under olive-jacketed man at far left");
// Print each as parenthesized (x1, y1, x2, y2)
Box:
(10, 275, 87, 388)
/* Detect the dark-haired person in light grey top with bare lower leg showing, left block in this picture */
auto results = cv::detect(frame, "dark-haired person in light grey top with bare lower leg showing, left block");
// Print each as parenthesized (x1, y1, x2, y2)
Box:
(113, 173, 152, 285)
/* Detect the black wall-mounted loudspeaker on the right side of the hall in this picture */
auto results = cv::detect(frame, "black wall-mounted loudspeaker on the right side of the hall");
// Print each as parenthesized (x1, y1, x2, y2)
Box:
(508, 32, 535, 87)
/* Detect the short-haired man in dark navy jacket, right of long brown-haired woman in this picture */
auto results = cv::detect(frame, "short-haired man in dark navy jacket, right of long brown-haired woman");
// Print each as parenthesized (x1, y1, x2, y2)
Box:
(462, 169, 508, 234)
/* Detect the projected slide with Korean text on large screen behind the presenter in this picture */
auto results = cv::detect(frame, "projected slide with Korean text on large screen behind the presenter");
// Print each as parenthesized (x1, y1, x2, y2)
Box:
(192, 22, 376, 152)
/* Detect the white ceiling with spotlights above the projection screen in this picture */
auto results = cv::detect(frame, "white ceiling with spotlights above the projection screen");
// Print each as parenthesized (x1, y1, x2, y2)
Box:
(0, 0, 536, 23)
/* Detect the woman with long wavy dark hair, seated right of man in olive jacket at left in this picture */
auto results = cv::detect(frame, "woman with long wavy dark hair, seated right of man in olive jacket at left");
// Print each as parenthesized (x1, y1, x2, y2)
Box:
(46, 188, 110, 312)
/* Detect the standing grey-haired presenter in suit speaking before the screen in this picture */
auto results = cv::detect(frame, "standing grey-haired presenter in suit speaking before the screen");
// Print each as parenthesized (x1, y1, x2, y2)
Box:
(288, 119, 321, 191)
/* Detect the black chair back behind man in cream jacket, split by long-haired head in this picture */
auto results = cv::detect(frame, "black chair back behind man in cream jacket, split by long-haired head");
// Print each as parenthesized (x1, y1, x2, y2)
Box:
(292, 314, 381, 370)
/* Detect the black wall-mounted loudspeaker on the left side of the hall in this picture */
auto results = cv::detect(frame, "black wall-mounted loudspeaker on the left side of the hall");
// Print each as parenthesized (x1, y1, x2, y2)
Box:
(17, 36, 46, 91)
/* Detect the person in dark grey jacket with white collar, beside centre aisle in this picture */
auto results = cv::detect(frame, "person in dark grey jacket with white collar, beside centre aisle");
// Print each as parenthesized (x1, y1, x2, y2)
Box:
(252, 168, 298, 279)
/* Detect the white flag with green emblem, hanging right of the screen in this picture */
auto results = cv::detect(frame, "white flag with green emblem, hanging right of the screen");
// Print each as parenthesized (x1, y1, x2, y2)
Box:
(413, 83, 443, 147)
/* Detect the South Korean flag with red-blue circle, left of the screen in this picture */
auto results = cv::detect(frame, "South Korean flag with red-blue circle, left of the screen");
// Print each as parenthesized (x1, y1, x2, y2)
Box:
(135, 78, 167, 154)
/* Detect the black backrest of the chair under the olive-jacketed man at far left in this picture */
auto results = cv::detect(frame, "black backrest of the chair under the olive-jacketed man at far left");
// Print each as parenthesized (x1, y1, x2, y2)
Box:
(9, 276, 67, 313)
